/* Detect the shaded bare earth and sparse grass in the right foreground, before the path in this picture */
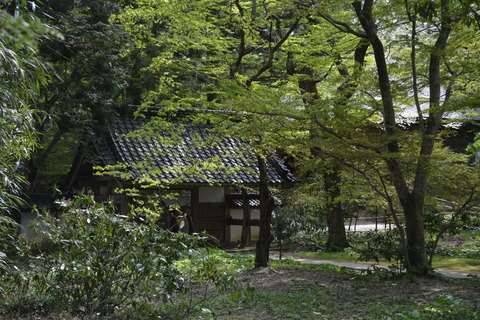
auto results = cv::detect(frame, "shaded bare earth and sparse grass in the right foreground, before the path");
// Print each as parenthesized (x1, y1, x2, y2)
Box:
(215, 268, 480, 320)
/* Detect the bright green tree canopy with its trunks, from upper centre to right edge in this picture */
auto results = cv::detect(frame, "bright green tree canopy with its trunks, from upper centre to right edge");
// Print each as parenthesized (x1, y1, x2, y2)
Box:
(114, 0, 479, 271)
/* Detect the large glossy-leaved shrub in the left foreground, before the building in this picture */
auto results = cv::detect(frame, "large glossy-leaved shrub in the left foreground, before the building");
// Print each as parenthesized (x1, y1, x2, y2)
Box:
(1, 196, 231, 319)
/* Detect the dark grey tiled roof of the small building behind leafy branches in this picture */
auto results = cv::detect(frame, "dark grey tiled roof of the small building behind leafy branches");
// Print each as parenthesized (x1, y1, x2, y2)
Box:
(95, 118, 295, 184)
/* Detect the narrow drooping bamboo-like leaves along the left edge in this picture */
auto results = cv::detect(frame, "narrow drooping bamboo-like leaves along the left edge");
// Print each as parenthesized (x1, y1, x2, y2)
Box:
(0, 10, 57, 212)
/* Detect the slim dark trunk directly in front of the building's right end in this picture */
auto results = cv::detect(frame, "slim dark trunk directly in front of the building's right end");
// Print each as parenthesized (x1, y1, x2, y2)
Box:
(255, 156, 275, 268)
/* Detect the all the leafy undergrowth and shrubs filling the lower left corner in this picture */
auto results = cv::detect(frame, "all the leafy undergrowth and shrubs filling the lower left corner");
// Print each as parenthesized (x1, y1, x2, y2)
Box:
(0, 196, 241, 319)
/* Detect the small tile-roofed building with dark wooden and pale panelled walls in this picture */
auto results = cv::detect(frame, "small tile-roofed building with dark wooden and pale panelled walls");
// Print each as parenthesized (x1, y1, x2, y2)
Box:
(66, 110, 296, 243)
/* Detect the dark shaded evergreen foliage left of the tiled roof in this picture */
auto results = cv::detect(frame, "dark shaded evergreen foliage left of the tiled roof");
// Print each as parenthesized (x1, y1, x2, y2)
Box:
(27, 0, 135, 192)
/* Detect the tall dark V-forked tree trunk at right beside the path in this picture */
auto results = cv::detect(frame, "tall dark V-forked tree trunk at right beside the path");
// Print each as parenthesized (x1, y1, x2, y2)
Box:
(353, 0, 452, 274)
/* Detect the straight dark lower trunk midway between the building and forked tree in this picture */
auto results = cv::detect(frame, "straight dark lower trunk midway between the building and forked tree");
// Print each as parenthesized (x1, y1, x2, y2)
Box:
(323, 165, 350, 251)
